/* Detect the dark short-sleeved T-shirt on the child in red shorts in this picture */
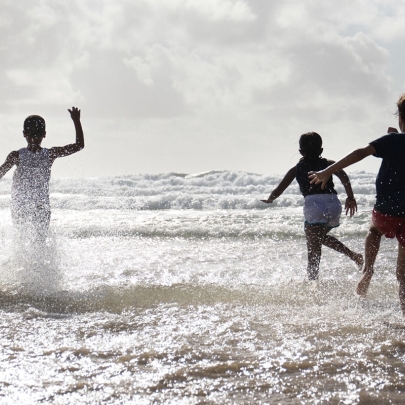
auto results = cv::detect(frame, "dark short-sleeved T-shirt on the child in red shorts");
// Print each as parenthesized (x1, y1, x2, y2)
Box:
(370, 133, 405, 217)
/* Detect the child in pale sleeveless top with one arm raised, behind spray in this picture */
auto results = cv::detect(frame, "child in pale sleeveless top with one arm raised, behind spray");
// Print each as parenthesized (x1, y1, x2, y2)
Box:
(0, 107, 84, 242)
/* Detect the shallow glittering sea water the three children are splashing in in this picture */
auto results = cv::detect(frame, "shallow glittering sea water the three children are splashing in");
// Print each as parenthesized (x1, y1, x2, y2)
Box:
(0, 172, 405, 404)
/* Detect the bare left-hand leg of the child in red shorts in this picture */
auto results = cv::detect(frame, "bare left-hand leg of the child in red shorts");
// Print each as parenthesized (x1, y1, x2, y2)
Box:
(356, 223, 383, 297)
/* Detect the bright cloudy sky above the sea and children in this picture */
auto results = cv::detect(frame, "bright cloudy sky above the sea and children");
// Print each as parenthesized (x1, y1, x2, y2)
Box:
(0, 0, 405, 177)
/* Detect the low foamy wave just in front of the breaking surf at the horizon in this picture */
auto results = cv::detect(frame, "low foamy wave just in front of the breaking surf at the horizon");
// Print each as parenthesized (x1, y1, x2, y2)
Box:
(43, 207, 370, 239)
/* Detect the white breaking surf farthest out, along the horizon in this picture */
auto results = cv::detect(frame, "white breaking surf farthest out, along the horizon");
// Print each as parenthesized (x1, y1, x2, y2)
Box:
(0, 170, 375, 210)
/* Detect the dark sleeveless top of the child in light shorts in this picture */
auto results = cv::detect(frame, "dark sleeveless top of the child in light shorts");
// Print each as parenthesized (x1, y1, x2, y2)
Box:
(295, 158, 337, 197)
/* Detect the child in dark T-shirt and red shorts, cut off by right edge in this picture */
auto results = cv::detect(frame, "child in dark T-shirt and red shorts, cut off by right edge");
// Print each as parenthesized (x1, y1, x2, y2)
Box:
(309, 94, 405, 316)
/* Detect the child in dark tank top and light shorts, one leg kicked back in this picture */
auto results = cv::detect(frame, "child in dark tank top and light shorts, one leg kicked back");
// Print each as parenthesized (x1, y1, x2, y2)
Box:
(261, 132, 363, 280)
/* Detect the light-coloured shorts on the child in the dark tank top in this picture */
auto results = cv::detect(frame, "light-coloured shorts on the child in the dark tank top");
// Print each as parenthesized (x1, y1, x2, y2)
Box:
(304, 194, 342, 228)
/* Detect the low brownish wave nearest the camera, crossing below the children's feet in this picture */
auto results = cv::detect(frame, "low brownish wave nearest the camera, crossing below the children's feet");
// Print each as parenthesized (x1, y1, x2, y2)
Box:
(0, 278, 398, 319)
